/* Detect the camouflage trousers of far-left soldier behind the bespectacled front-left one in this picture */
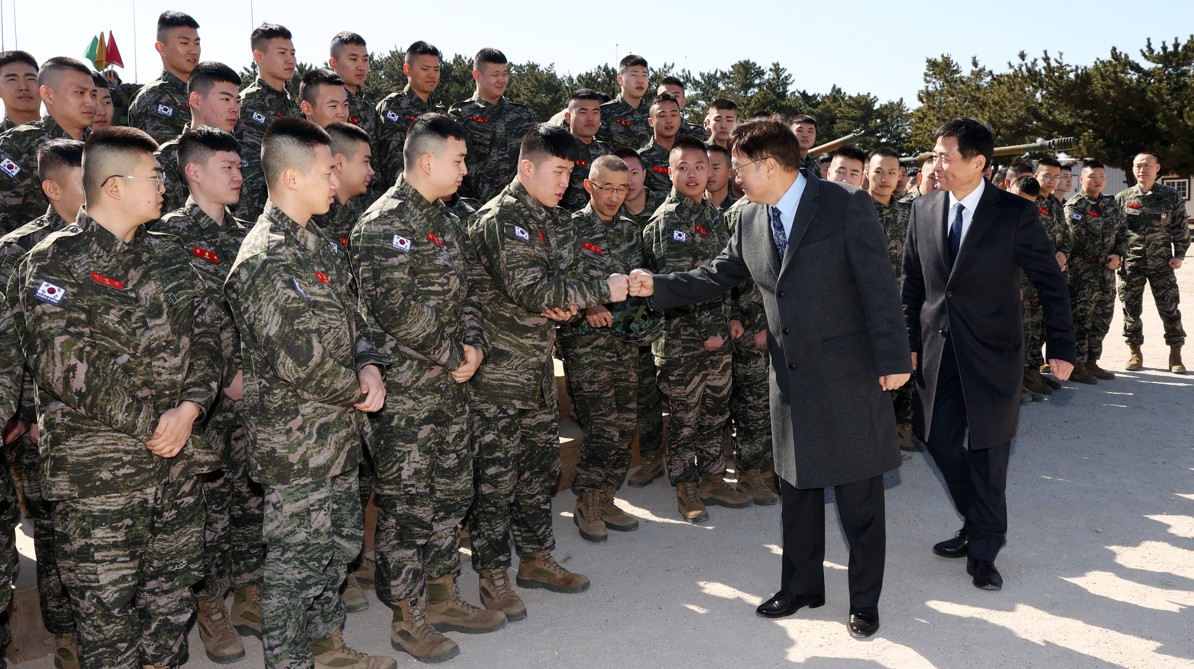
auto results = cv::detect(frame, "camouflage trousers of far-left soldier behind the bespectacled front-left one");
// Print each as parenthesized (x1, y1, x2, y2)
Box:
(12, 434, 75, 634)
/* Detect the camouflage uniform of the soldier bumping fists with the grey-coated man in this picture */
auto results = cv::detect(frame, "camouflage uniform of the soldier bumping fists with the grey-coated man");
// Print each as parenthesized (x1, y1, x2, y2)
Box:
(468, 179, 609, 570)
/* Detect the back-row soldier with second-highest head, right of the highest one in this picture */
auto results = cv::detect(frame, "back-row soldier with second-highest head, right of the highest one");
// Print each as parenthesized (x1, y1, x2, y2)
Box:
(233, 23, 302, 221)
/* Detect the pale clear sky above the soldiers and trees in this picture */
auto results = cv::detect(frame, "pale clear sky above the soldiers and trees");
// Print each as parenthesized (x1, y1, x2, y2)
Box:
(0, 0, 1194, 108)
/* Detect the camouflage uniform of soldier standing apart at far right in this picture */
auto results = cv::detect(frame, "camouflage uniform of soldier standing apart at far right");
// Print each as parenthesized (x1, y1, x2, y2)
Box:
(1115, 184, 1190, 346)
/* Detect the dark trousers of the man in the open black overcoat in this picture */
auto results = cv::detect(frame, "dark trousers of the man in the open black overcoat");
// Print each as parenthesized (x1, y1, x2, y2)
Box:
(927, 339, 1011, 560)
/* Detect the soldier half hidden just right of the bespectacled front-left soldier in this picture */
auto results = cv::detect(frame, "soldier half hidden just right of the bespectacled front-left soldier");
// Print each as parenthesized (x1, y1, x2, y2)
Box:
(154, 125, 265, 663)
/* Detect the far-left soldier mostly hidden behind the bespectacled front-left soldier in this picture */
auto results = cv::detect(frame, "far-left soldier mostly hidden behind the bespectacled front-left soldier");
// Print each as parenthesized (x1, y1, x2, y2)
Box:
(0, 140, 84, 668)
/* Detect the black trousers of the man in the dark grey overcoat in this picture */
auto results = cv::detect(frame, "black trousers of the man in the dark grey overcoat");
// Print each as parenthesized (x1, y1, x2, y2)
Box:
(780, 474, 887, 608)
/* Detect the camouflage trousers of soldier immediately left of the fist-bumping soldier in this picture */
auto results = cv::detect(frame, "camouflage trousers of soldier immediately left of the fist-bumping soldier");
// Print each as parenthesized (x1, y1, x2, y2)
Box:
(369, 391, 473, 601)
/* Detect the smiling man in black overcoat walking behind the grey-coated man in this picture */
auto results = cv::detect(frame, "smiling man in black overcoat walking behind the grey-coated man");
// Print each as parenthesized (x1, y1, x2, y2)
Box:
(903, 118, 1076, 590)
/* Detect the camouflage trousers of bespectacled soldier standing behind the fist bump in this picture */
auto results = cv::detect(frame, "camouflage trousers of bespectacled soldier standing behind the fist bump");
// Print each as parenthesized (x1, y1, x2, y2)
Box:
(561, 335, 639, 495)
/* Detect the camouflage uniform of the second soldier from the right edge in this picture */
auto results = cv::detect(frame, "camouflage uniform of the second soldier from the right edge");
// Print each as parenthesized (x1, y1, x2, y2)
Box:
(1065, 190, 1127, 363)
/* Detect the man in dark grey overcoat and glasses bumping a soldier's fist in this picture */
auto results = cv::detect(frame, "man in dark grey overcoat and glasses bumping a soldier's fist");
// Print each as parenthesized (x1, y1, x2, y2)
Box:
(630, 119, 911, 637)
